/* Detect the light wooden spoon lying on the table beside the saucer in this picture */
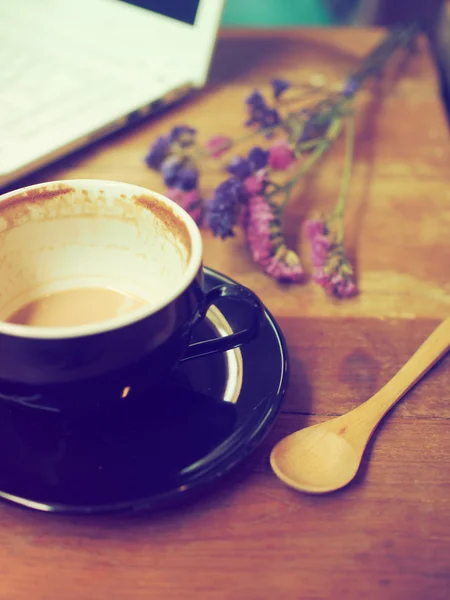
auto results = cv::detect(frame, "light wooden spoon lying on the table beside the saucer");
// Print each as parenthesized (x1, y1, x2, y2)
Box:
(270, 318, 450, 494)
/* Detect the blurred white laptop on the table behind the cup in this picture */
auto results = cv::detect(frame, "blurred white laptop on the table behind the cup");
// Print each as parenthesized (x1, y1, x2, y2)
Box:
(0, 0, 224, 187)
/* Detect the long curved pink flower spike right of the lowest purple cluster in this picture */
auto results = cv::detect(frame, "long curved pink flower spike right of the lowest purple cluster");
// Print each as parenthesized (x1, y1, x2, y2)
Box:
(244, 195, 303, 282)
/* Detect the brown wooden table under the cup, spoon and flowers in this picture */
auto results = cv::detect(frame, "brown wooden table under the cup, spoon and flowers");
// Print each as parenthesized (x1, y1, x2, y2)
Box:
(0, 30, 450, 600)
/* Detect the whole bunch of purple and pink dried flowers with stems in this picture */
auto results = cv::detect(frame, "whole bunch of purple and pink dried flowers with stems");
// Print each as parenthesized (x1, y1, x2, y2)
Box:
(145, 25, 419, 298)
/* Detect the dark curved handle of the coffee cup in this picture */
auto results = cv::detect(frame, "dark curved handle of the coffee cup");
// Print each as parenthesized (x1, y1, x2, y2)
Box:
(181, 283, 264, 362)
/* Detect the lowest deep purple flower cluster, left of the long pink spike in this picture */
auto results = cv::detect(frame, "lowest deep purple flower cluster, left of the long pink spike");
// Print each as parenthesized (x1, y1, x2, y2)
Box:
(208, 177, 246, 239)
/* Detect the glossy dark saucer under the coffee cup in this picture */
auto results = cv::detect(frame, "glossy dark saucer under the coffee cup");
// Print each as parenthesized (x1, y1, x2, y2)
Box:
(0, 269, 287, 513)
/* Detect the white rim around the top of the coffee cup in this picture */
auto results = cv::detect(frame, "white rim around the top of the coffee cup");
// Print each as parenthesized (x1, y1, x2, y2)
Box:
(0, 179, 203, 340)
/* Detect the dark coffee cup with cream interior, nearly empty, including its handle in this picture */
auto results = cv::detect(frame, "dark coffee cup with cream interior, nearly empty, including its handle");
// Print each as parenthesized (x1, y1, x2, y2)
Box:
(0, 180, 262, 387)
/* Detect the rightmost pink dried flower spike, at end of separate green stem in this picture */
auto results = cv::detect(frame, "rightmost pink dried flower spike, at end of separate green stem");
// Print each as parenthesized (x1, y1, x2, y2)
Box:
(305, 219, 358, 298)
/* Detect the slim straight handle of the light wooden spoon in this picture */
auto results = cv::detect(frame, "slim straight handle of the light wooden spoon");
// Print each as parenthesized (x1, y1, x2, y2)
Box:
(352, 318, 450, 428)
